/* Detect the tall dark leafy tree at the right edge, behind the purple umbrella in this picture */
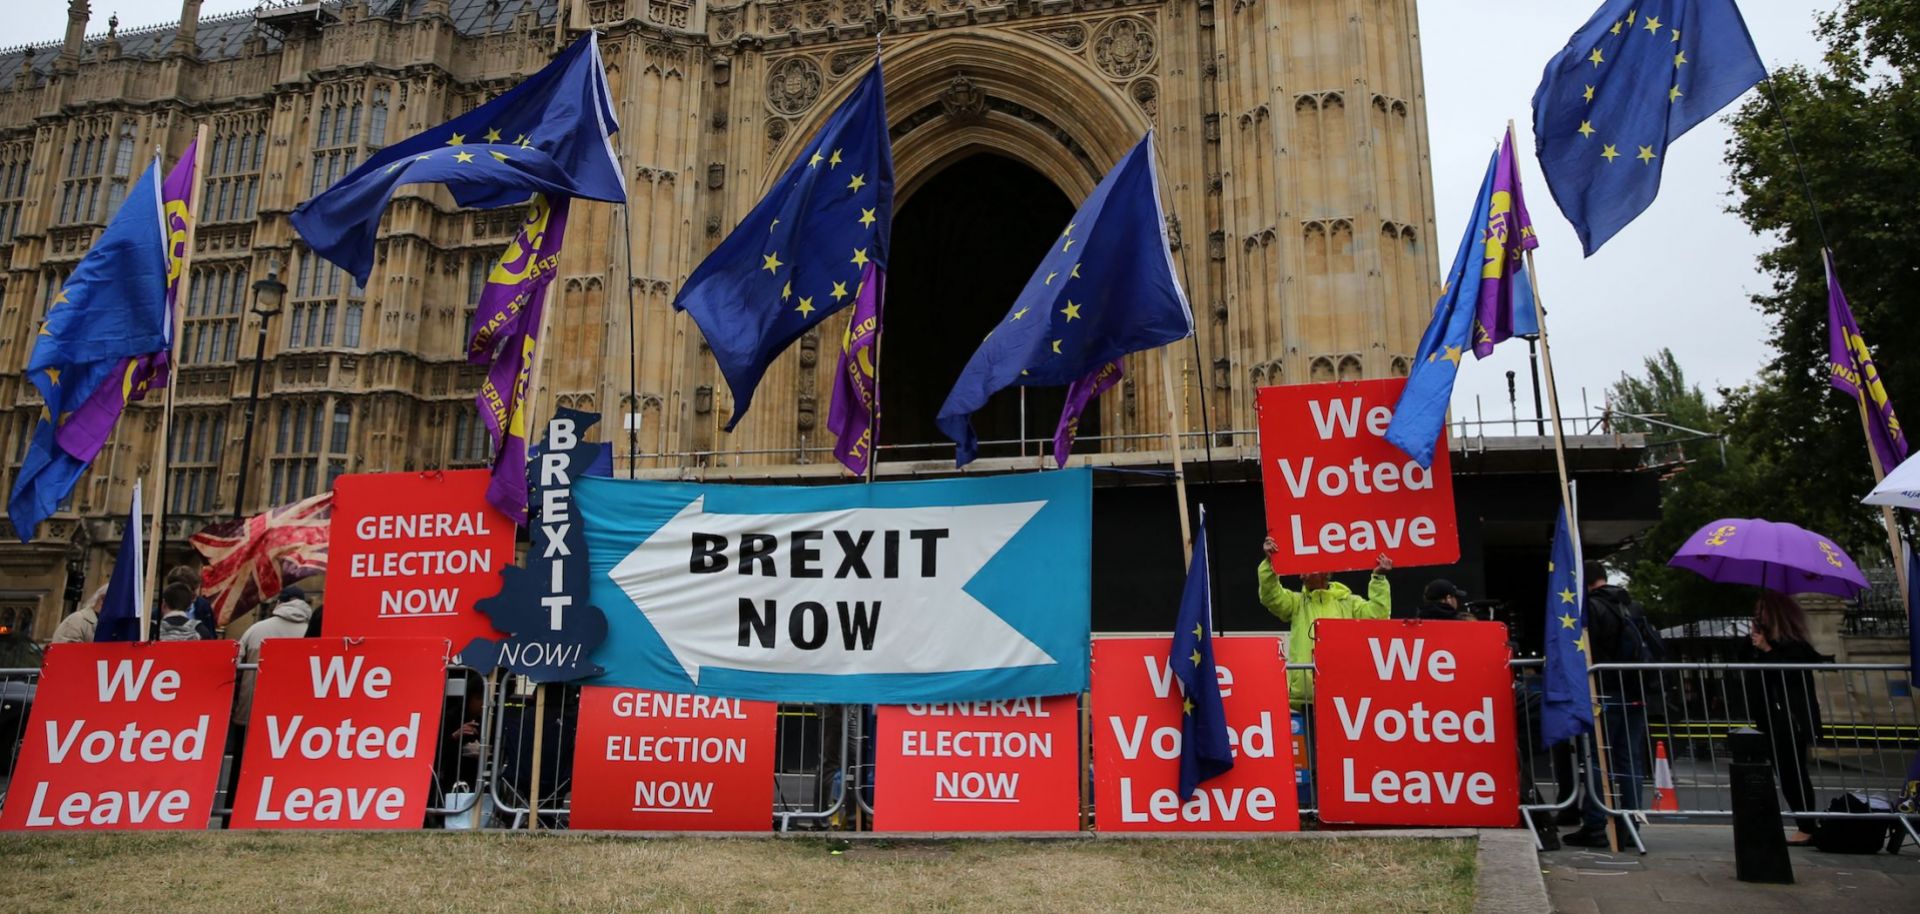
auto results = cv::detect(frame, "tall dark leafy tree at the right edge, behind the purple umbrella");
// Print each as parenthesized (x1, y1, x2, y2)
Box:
(1720, 0, 1920, 565)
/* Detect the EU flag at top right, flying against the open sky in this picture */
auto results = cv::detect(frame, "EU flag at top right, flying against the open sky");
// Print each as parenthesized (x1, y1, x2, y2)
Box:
(1534, 0, 1766, 255)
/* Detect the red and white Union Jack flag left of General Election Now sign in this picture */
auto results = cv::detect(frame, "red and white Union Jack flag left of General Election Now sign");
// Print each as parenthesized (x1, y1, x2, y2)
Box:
(188, 492, 334, 626)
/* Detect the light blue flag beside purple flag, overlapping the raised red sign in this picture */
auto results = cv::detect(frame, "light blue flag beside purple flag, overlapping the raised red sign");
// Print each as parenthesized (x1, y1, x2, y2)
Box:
(1380, 152, 1505, 469)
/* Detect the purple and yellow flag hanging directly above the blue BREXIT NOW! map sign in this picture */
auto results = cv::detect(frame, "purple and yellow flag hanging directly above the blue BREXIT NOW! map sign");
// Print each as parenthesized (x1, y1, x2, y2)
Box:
(467, 194, 568, 524)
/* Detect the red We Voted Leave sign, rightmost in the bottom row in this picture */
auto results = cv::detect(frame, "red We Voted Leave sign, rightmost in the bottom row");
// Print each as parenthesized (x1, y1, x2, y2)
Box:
(1313, 620, 1519, 828)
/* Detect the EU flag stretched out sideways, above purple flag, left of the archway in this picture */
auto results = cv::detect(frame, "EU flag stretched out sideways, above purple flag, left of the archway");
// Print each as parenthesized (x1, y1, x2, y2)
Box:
(288, 33, 626, 286)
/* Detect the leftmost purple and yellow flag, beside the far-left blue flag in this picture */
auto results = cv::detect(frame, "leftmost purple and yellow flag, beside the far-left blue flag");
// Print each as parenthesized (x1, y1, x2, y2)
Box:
(54, 140, 200, 461)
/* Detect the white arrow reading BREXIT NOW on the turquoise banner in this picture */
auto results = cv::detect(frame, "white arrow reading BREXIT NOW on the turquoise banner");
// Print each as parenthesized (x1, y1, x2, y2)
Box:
(607, 495, 1054, 684)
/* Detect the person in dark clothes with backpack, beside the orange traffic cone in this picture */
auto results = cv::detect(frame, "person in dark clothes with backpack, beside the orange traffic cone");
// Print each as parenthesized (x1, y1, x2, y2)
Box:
(1561, 563, 1667, 847)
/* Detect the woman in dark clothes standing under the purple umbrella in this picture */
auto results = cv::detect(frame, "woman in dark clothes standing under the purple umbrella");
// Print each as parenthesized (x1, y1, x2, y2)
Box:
(1741, 591, 1834, 847)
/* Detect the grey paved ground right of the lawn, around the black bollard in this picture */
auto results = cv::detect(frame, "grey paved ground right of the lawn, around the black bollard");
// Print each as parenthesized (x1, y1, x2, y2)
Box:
(1540, 824, 1920, 914)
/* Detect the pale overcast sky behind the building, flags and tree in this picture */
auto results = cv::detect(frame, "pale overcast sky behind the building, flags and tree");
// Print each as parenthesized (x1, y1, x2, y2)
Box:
(22, 0, 1837, 419)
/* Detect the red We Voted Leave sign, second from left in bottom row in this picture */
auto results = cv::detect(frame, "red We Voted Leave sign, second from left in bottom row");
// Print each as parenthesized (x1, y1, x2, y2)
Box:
(232, 637, 449, 828)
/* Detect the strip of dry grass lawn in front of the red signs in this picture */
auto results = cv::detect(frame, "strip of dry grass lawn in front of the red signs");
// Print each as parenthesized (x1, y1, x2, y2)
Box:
(0, 831, 1475, 914)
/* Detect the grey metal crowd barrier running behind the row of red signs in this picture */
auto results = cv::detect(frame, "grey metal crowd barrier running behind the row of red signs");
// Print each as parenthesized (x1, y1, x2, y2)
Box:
(0, 661, 1920, 851)
